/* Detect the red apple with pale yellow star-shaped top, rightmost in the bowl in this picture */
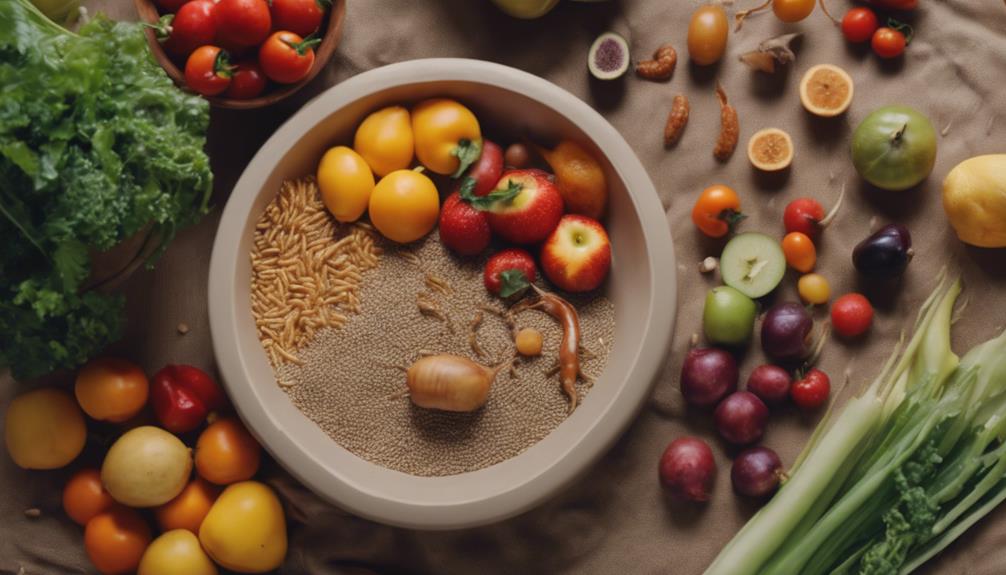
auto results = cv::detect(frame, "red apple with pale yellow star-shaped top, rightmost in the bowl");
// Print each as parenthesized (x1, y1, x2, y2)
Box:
(541, 214, 612, 292)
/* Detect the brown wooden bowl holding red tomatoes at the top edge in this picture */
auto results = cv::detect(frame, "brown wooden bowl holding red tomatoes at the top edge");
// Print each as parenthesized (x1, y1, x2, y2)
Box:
(133, 0, 346, 110)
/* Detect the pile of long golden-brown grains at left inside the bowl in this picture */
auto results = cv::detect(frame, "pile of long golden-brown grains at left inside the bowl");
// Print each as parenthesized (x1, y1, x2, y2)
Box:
(252, 178, 380, 367)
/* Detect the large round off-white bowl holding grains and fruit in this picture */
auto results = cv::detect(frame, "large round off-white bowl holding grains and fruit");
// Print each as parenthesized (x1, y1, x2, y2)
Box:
(209, 59, 676, 529)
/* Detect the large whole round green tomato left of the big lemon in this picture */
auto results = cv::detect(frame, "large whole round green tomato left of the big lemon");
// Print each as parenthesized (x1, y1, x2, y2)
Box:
(852, 106, 937, 191)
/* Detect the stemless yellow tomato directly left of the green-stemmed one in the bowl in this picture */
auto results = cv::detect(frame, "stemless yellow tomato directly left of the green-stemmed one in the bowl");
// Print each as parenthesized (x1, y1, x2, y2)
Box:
(353, 106, 415, 176)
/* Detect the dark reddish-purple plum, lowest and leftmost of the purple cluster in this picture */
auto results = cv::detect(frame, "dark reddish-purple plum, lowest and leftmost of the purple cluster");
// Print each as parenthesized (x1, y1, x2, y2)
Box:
(658, 437, 716, 503)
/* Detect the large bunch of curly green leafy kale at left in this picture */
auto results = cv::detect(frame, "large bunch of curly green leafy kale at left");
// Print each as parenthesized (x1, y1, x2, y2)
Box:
(0, 0, 212, 378)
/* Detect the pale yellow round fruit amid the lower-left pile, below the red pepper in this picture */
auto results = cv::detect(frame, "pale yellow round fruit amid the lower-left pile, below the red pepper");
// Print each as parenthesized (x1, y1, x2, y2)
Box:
(102, 425, 192, 508)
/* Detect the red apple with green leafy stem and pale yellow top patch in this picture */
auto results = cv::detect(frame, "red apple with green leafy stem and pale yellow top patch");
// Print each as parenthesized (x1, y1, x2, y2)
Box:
(487, 170, 562, 244)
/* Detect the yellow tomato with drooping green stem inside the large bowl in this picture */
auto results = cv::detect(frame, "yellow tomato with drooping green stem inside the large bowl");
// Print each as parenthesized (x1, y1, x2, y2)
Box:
(412, 98, 482, 177)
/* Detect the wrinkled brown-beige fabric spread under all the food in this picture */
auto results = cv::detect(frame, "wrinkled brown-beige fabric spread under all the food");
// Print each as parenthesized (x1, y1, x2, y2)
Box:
(0, 0, 1006, 575)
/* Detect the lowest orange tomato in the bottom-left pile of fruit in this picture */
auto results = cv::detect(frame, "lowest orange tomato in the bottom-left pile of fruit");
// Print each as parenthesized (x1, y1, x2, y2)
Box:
(83, 505, 150, 575)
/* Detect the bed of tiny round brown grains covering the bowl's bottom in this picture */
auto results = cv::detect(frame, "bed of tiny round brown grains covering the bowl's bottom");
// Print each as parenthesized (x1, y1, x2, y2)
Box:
(277, 232, 615, 475)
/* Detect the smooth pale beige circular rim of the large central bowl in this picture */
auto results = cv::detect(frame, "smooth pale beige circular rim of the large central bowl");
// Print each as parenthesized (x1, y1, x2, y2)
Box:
(208, 58, 677, 529)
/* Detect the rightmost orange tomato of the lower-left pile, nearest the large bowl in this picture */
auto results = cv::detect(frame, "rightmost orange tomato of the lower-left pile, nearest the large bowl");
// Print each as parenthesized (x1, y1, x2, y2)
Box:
(195, 417, 262, 486)
